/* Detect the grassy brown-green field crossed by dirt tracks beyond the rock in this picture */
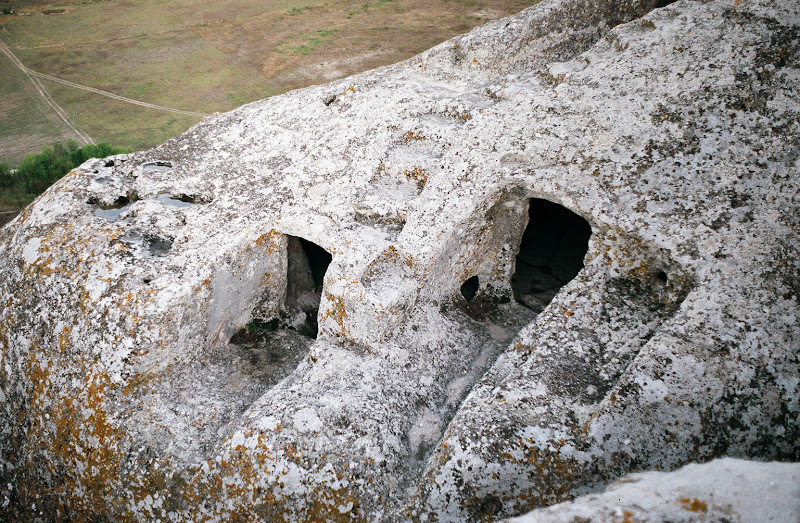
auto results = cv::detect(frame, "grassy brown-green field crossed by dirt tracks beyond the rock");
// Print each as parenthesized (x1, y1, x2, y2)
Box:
(0, 0, 536, 166)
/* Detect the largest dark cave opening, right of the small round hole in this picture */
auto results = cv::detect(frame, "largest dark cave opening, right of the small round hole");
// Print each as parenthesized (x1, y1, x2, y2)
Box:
(511, 198, 592, 312)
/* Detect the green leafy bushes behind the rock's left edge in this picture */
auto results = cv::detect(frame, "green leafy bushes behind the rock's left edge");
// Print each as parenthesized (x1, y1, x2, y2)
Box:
(0, 140, 131, 201)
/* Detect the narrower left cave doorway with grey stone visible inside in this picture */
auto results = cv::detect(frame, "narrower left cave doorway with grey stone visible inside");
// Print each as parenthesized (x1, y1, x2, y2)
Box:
(285, 236, 333, 338)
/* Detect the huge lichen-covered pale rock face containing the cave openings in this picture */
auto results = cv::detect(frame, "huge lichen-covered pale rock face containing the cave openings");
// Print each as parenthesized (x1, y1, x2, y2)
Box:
(0, 0, 800, 521)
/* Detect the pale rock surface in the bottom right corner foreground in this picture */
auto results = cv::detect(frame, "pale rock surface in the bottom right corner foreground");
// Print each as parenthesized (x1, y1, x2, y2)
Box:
(508, 458, 800, 523)
